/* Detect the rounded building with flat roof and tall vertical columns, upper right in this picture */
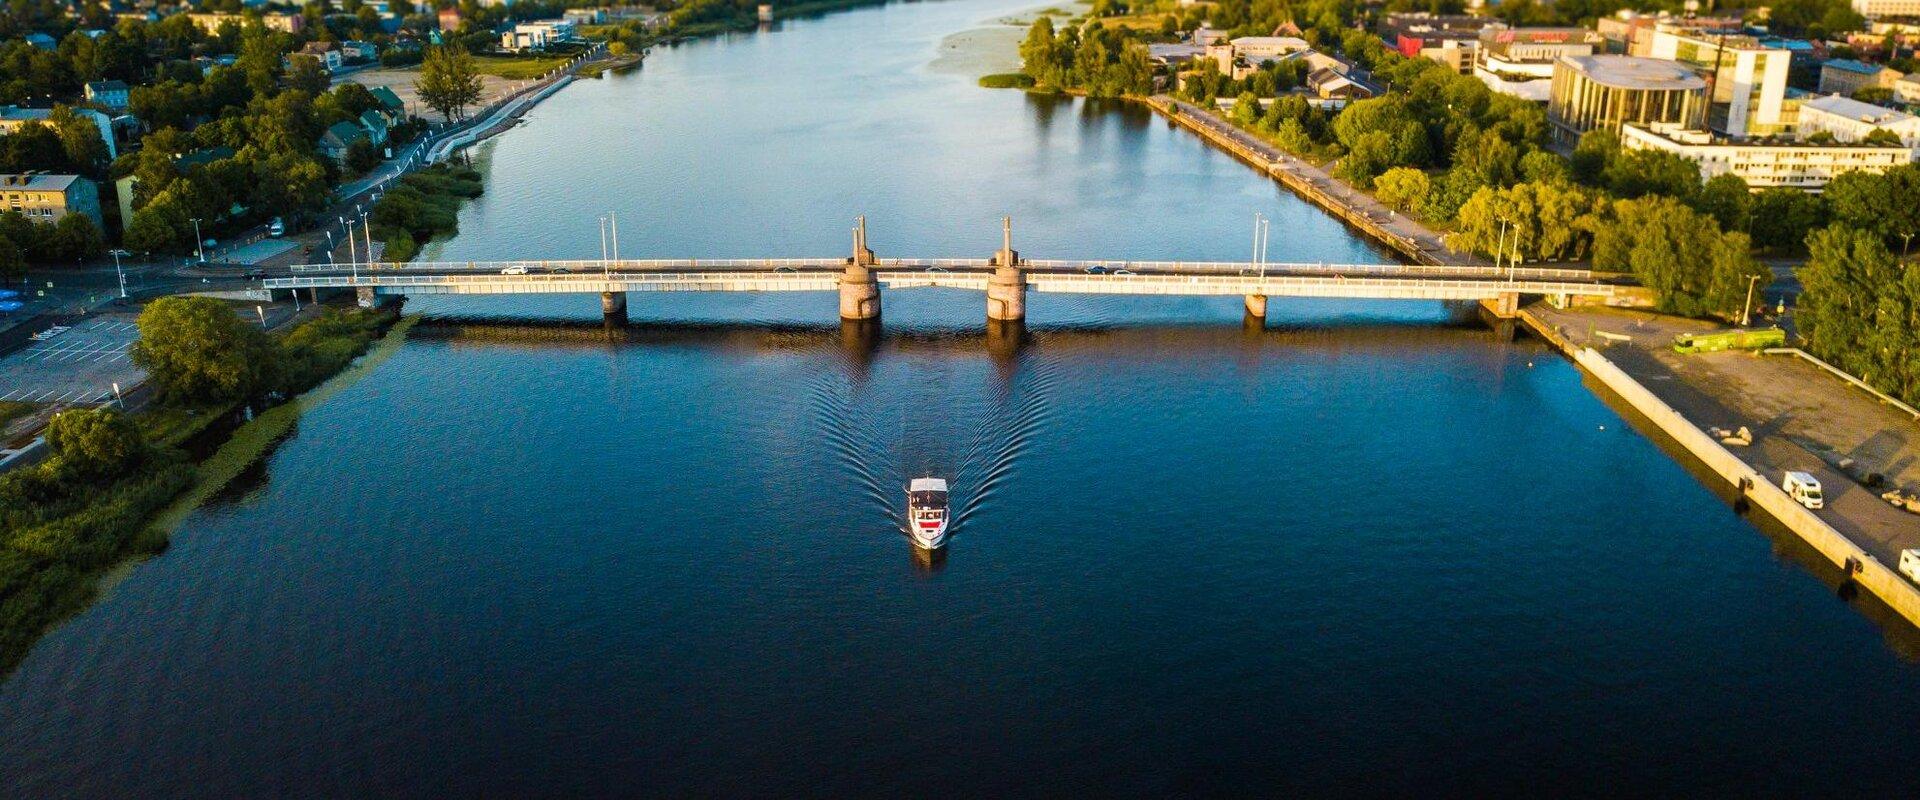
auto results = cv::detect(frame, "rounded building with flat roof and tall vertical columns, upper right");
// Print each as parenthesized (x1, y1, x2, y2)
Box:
(1548, 56, 1707, 142)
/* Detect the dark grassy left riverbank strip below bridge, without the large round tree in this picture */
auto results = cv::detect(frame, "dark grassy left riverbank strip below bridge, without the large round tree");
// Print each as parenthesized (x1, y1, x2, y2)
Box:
(0, 309, 405, 673)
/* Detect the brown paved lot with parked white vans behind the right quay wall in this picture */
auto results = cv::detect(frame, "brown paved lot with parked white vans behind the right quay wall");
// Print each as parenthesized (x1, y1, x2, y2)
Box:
(1530, 303, 1920, 564)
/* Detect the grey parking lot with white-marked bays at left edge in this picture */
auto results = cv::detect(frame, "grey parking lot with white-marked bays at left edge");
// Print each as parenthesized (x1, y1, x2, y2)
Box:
(0, 315, 146, 405)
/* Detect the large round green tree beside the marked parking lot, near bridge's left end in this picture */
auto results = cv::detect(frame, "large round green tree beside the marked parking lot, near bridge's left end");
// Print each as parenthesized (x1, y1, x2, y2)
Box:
(132, 297, 276, 403)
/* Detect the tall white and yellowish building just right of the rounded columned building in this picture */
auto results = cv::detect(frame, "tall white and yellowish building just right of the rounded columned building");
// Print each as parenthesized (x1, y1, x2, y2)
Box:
(1647, 25, 1793, 136)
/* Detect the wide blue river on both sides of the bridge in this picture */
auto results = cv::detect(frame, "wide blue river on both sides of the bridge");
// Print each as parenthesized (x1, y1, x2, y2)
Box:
(0, 0, 1920, 796)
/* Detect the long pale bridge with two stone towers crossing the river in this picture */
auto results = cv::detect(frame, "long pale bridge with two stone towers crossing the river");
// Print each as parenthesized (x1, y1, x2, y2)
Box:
(261, 219, 1619, 320)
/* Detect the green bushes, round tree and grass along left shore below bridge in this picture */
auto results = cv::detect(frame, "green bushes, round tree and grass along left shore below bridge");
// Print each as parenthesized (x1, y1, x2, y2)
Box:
(0, 297, 407, 673)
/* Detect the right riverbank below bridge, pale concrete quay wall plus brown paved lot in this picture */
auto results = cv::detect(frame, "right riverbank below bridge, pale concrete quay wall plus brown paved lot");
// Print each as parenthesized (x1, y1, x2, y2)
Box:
(1521, 303, 1920, 625)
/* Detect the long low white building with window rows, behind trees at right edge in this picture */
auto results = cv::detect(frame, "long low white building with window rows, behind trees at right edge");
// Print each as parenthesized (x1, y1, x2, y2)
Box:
(1620, 125, 1914, 192)
